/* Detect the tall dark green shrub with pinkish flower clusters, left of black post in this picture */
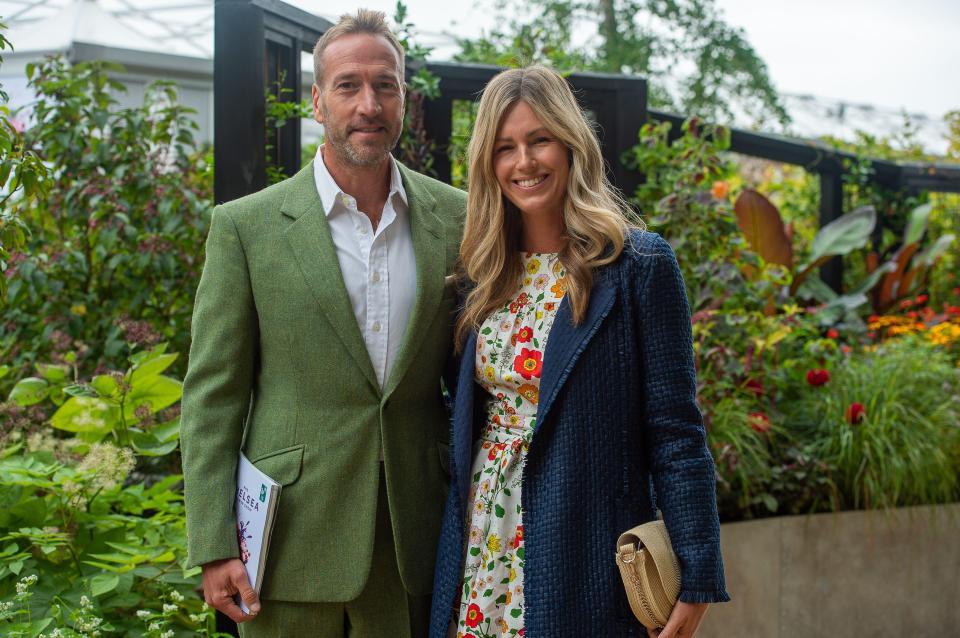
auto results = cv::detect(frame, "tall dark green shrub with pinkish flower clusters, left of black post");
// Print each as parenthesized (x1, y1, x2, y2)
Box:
(0, 58, 212, 380)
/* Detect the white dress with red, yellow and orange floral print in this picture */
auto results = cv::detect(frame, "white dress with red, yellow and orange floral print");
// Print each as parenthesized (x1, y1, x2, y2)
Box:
(451, 253, 566, 638)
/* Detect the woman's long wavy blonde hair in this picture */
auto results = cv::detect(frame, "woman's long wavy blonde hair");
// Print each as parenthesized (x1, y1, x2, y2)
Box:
(455, 66, 641, 351)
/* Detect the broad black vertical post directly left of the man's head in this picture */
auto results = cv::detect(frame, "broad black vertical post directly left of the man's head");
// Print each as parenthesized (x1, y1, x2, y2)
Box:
(213, 0, 266, 203)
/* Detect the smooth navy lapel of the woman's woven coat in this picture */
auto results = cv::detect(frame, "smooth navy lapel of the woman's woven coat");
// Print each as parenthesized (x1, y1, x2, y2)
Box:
(536, 277, 616, 429)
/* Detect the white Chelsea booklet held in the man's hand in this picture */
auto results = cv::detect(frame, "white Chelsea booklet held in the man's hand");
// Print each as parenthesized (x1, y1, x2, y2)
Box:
(237, 452, 280, 614)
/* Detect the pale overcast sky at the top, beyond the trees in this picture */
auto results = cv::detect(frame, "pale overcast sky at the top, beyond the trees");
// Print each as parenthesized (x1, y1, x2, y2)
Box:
(287, 0, 960, 118)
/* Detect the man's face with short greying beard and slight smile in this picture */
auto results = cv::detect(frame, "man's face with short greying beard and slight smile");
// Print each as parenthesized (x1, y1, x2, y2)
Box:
(313, 33, 404, 167)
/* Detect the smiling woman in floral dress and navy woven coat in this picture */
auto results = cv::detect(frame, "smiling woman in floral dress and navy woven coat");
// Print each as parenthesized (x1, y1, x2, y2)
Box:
(430, 67, 728, 638)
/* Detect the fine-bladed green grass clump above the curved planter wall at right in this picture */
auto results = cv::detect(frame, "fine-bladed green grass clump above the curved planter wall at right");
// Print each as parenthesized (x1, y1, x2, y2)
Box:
(783, 339, 960, 508)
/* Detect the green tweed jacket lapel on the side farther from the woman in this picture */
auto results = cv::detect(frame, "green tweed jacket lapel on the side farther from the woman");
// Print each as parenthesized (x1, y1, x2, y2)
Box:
(280, 162, 380, 392)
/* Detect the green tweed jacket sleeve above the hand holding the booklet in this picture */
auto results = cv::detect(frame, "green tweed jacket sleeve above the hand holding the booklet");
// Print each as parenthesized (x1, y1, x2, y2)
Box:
(180, 207, 258, 566)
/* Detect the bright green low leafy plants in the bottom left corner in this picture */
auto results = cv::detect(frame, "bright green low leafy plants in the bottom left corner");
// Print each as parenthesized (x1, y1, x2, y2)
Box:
(0, 345, 229, 637)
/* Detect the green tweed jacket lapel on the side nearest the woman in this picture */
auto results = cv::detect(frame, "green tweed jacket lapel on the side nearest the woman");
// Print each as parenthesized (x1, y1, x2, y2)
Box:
(384, 165, 446, 398)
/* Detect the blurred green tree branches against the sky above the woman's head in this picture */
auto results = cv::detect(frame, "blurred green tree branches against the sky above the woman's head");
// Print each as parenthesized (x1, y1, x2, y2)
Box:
(456, 0, 789, 125)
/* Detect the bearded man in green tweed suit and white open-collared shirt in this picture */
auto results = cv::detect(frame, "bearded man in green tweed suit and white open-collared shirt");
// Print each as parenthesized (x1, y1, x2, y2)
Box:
(182, 10, 466, 638)
